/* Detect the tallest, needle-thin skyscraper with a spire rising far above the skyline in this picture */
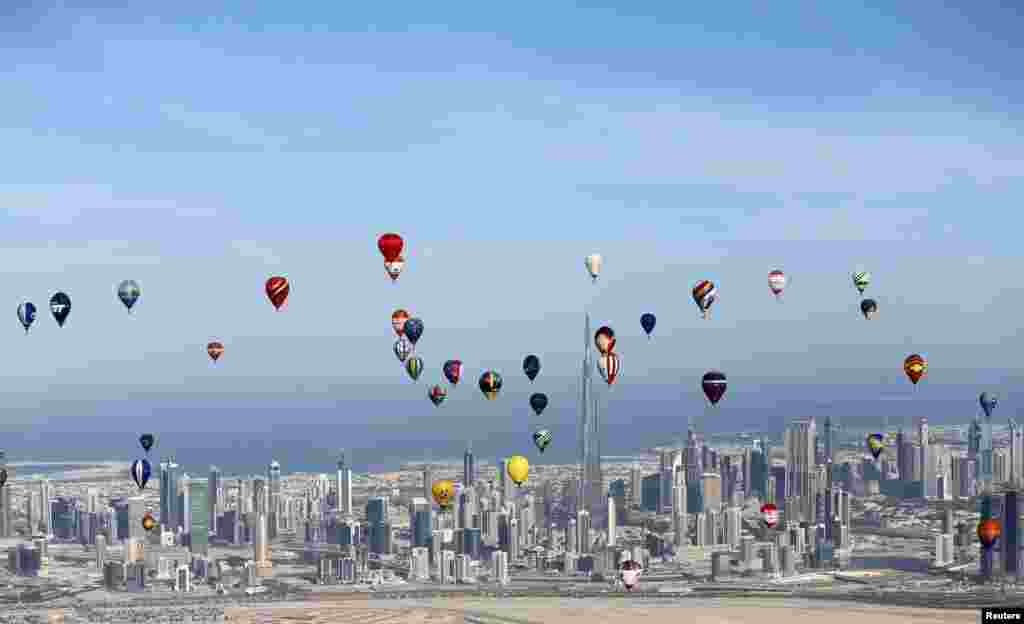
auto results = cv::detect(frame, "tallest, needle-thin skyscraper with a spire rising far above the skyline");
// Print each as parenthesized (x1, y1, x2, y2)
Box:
(577, 314, 607, 527)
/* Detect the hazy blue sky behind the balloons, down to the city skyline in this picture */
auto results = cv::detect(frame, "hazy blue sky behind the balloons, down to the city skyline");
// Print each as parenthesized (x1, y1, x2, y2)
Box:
(0, 0, 1024, 467)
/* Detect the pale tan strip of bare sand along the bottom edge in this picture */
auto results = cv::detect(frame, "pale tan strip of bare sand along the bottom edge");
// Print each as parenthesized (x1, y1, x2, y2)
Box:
(225, 598, 978, 624)
